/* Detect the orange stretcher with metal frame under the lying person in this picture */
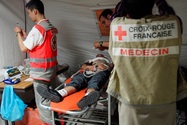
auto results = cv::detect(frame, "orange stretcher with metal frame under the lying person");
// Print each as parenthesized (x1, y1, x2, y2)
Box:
(40, 71, 114, 125)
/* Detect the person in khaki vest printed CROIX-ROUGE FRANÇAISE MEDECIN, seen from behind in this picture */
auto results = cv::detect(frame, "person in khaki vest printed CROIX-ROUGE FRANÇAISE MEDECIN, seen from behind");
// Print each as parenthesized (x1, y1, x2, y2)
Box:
(107, 0, 182, 125)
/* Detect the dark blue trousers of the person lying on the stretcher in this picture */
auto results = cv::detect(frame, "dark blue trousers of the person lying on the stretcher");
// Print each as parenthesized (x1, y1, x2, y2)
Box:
(67, 70, 110, 91)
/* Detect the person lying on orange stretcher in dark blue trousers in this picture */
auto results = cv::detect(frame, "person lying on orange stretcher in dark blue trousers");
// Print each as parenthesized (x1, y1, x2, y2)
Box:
(37, 54, 113, 109)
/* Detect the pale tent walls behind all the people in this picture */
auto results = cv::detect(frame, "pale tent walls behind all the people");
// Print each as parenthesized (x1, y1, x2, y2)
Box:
(0, 0, 187, 125)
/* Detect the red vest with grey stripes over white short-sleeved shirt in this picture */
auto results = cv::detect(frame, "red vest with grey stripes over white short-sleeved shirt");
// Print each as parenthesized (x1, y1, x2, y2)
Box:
(24, 19, 58, 81)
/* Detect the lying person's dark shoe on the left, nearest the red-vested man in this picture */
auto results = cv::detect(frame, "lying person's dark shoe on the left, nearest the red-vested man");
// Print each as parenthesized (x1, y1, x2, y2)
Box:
(36, 84, 62, 102)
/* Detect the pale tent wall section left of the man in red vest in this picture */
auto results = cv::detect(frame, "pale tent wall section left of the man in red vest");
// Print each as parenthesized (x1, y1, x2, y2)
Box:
(0, 0, 25, 68)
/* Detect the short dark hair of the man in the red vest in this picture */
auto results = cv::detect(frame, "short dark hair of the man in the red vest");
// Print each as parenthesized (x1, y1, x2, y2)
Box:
(26, 0, 44, 14)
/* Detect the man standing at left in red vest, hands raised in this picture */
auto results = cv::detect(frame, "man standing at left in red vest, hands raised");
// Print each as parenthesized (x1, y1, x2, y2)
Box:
(14, 0, 61, 124)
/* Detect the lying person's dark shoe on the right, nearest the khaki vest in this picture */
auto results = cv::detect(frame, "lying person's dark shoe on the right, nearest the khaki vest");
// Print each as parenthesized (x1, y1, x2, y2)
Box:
(77, 91, 100, 109)
